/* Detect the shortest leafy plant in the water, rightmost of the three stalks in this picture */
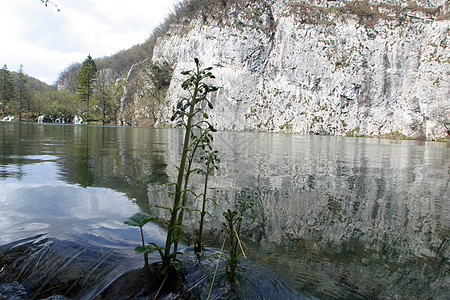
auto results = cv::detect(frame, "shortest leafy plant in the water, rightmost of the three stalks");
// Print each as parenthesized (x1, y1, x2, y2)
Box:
(223, 197, 253, 285)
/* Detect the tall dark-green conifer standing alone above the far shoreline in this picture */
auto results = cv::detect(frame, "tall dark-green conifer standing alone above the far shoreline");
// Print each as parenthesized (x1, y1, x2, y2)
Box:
(78, 54, 97, 122)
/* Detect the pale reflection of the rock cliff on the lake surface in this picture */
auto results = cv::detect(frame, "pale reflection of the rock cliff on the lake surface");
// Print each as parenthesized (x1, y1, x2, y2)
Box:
(149, 133, 450, 298)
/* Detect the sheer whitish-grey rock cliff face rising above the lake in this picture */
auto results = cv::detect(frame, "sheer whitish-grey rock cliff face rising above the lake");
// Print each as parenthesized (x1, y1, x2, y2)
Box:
(125, 1, 450, 140)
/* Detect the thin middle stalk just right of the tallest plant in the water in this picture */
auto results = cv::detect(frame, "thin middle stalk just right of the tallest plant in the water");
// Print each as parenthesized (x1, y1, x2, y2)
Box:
(194, 144, 220, 253)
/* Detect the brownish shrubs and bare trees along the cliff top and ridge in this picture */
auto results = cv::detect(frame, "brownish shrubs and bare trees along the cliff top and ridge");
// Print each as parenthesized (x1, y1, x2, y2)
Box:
(57, 0, 450, 90)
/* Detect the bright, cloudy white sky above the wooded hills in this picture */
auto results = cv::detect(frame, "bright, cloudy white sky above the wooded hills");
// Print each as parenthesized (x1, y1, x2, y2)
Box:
(0, 0, 179, 84)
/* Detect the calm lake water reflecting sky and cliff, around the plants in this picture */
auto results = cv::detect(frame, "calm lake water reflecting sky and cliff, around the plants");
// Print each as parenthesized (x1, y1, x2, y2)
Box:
(0, 122, 450, 299)
